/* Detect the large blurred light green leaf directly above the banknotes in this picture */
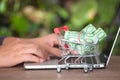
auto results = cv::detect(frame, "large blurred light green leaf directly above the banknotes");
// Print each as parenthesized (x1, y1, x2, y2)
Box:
(70, 0, 97, 29)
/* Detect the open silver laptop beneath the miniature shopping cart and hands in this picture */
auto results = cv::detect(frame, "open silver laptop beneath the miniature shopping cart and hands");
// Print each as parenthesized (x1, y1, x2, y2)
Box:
(24, 27, 120, 70)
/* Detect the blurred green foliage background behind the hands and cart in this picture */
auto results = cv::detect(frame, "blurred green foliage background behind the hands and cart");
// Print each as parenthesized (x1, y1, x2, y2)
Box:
(0, 0, 120, 55)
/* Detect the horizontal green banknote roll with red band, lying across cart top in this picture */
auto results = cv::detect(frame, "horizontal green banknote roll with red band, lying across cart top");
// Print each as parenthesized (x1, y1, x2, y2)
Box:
(64, 31, 98, 44)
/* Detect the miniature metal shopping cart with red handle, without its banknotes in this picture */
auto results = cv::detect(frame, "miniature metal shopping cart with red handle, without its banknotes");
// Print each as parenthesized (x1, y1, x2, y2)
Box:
(54, 26, 99, 73)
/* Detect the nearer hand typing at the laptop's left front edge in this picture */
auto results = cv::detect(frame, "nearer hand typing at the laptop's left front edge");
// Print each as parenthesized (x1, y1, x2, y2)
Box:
(0, 38, 49, 67)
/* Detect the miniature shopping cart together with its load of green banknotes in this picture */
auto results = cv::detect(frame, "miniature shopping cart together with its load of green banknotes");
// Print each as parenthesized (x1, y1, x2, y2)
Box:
(54, 24, 106, 73)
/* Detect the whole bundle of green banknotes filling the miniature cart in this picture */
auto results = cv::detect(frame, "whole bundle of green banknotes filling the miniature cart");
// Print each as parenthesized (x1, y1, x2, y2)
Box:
(64, 24, 107, 55)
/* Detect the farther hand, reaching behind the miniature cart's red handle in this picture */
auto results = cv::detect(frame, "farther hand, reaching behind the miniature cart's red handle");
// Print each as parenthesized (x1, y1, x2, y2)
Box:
(30, 34, 61, 57)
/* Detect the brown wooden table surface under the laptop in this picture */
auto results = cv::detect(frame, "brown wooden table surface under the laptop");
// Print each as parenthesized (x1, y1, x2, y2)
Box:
(0, 56, 120, 80)
